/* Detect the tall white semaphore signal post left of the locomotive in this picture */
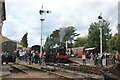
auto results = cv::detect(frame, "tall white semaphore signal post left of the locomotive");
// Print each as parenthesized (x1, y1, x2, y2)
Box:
(39, 6, 50, 58)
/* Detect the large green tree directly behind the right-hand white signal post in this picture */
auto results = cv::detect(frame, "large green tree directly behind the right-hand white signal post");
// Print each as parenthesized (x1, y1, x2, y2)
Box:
(87, 21, 111, 51)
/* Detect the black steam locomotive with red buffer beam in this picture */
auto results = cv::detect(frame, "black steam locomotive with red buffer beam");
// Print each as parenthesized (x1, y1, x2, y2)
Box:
(46, 44, 69, 62)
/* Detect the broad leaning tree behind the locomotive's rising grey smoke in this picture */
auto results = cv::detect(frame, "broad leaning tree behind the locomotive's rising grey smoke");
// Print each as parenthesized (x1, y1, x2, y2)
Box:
(44, 26, 78, 48)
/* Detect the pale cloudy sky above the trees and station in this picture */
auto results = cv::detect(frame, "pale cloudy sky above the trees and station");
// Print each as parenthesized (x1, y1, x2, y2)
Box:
(2, 0, 119, 47)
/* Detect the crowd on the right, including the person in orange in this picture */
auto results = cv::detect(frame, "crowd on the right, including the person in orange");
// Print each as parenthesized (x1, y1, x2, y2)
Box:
(81, 53, 119, 66)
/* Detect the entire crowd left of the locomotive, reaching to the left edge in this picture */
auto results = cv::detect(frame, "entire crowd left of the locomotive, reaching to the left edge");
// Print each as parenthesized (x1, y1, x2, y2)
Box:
(2, 48, 46, 64)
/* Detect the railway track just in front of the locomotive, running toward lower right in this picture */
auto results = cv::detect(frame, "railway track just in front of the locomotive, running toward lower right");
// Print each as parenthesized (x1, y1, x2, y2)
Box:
(47, 63, 102, 76)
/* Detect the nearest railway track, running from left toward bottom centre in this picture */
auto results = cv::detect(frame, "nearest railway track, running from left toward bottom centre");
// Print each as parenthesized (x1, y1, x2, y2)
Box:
(11, 65, 84, 80)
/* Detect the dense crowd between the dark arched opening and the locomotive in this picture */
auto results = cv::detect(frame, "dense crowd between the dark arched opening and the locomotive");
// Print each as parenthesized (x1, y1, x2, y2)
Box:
(16, 49, 45, 64)
